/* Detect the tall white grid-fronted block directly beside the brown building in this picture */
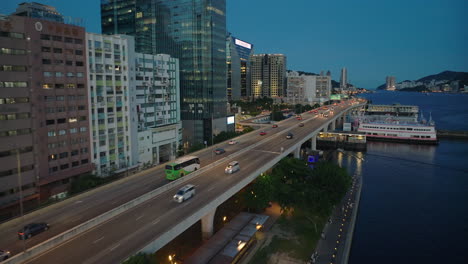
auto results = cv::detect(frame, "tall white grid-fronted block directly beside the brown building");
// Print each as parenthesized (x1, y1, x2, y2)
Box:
(86, 33, 138, 176)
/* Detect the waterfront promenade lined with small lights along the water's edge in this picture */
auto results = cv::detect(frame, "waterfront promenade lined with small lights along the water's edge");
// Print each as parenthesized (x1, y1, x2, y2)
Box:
(309, 175, 362, 264)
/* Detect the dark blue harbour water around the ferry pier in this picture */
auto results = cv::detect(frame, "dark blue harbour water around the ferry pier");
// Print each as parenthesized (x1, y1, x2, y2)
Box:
(336, 92, 468, 264)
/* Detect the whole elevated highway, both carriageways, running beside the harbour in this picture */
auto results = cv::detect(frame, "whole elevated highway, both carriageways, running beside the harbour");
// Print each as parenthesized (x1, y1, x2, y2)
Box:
(0, 99, 366, 263)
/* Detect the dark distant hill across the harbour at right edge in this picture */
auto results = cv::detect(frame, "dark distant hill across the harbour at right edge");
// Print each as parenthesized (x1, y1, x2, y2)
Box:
(377, 71, 468, 91)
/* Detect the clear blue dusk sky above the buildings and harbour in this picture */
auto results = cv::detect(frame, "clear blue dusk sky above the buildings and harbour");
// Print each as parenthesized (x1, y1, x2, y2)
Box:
(0, 0, 468, 89)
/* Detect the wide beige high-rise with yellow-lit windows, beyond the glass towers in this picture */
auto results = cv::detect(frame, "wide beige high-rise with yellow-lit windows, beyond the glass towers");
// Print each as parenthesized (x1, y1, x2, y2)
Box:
(250, 54, 286, 98)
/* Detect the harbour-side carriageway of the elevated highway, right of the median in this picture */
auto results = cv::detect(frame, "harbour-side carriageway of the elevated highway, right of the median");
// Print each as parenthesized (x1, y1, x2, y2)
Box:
(0, 99, 366, 263)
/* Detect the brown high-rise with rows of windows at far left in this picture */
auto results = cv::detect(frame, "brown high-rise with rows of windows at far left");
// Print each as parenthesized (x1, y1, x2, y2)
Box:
(0, 12, 92, 214)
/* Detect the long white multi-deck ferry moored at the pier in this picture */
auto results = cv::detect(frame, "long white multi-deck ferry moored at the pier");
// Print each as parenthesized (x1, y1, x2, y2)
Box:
(356, 105, 438, 144)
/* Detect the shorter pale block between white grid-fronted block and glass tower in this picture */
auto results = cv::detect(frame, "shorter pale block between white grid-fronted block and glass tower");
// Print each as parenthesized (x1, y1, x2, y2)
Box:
(135, 53, 182, 166)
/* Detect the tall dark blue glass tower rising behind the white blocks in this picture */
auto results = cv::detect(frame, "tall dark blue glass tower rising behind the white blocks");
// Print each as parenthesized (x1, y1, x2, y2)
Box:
(101, 0, 227, 143)
